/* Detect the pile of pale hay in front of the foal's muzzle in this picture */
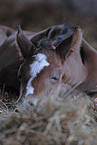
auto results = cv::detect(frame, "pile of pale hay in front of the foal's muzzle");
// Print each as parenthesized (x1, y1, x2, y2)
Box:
(0, 85, 97, 145)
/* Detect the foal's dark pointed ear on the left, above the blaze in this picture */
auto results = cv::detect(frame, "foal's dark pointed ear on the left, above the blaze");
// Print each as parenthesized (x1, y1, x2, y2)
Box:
(17, 26, 35, 58)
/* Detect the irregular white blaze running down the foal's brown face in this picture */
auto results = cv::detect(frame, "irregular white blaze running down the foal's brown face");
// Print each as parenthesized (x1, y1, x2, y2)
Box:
(25, 53, 50, 97)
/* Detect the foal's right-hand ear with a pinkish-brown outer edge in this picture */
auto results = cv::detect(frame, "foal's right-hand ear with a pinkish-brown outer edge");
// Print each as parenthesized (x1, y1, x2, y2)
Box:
(56, 27, 82, 60)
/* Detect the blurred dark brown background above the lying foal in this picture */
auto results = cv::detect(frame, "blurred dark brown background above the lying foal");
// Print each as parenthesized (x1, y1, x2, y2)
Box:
(0, 0, 97, 48)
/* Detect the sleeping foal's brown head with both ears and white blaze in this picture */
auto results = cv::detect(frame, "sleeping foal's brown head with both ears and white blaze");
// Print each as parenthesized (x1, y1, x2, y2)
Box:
(17, 25, 83, 101)
